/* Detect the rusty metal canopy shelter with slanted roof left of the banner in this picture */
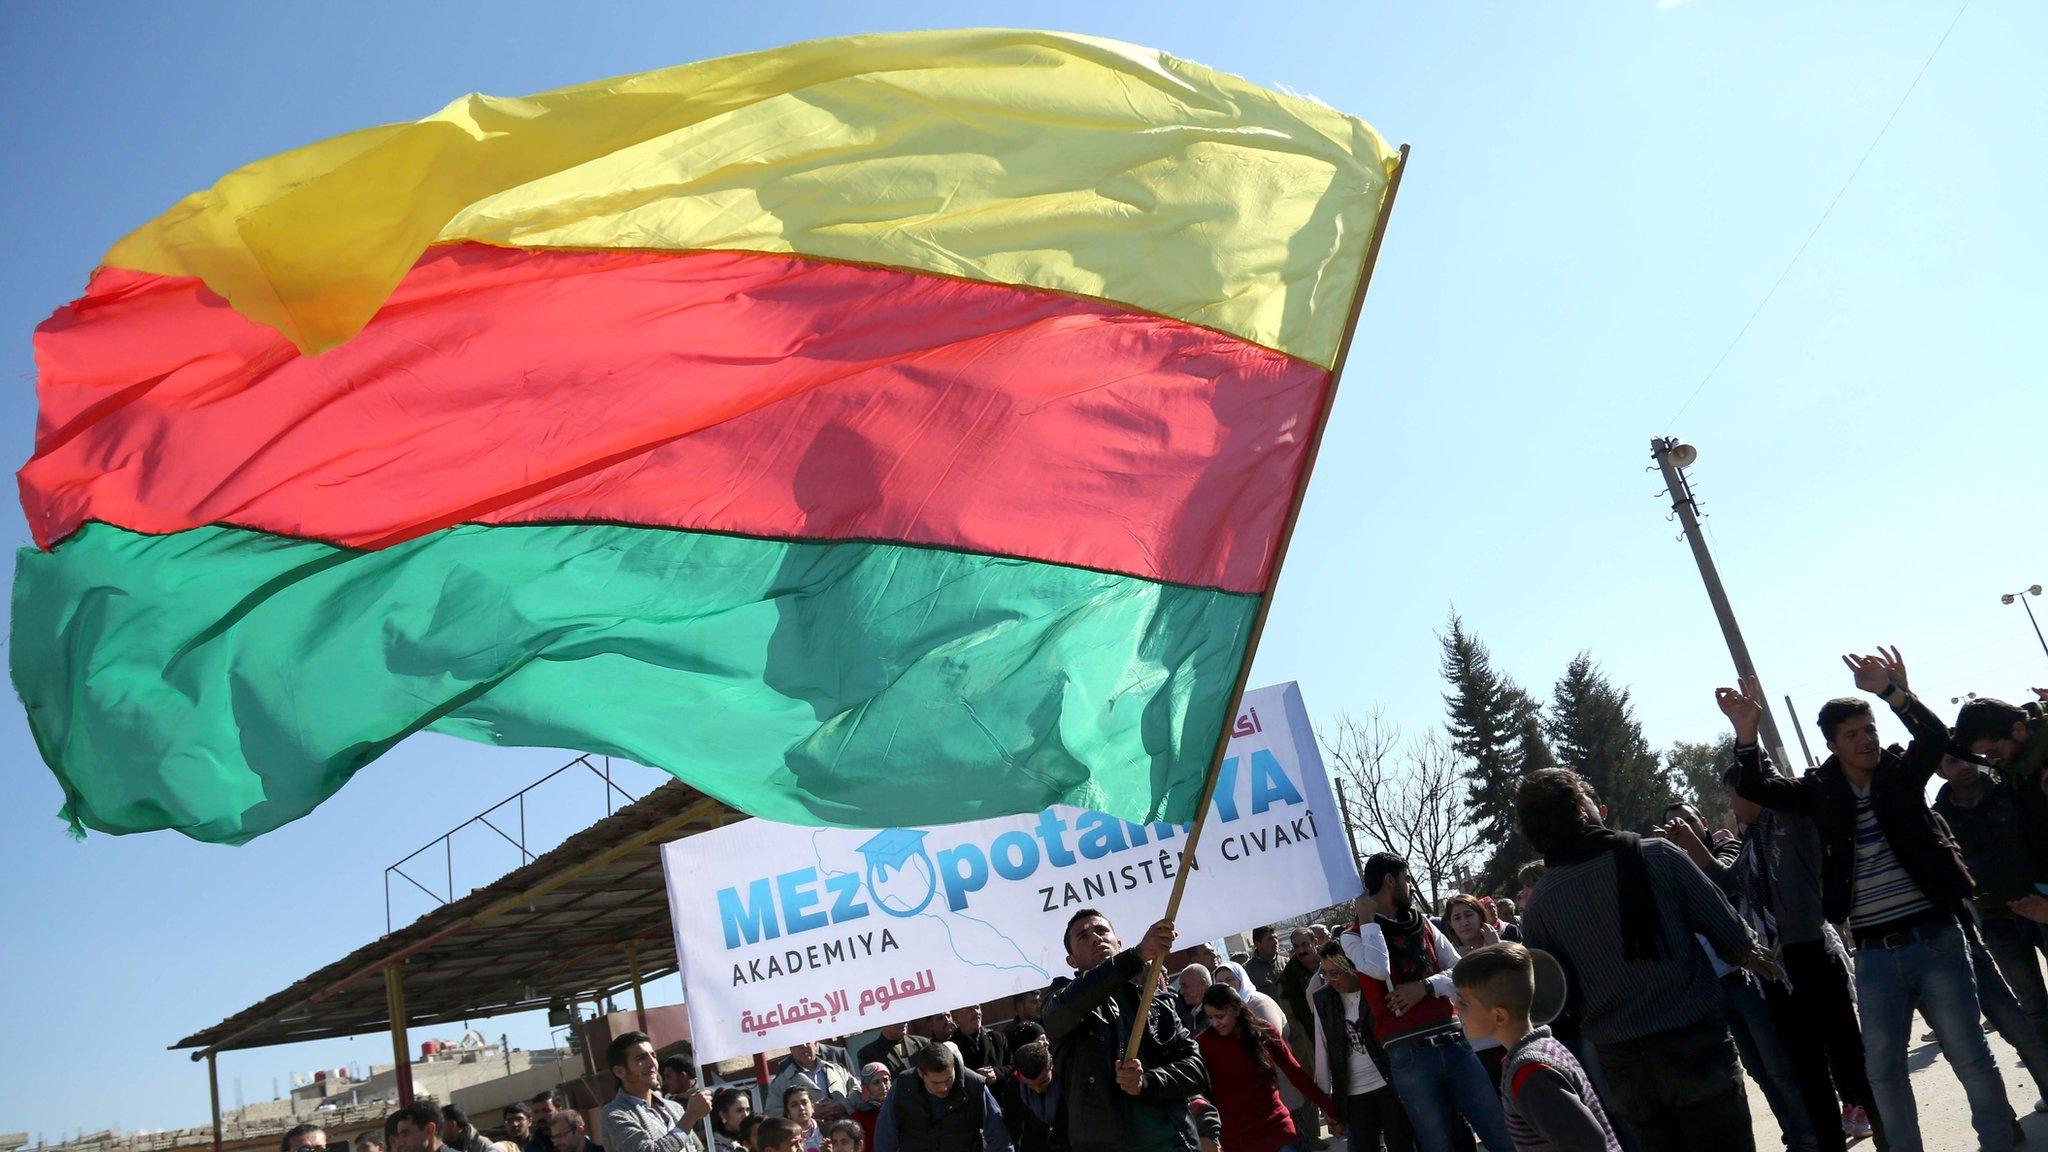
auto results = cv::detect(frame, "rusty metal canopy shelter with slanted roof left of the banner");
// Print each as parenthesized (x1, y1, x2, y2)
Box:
(170, 770, 743, 1146)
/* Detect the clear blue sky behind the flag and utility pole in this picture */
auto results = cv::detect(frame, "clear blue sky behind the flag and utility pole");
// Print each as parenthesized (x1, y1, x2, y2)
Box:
(0, 0, 2048, 1140)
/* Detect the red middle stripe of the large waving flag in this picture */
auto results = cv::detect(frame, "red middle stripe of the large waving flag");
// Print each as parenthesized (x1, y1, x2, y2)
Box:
(20, 246, 1329, 592)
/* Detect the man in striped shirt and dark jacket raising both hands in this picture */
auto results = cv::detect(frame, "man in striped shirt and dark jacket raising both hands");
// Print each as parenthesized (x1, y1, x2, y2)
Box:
(1714, 650, 2015, 1152)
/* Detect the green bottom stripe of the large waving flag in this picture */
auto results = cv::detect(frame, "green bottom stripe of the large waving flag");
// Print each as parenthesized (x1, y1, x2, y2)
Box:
(12, 525, 1257, 842)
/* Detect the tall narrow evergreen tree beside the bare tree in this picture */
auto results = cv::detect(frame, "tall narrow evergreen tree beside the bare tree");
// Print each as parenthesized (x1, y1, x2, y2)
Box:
(1438, 613, 1556, 892)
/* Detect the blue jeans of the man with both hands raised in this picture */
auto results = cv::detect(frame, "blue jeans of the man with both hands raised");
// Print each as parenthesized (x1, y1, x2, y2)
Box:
(1855, 920, 2013, 1152)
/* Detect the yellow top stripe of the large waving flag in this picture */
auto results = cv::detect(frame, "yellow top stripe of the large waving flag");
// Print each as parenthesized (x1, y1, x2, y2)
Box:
(106, 31, 1395, 367)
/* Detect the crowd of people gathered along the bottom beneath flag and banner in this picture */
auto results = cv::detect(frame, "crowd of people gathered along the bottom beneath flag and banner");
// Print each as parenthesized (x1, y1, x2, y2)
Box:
(296, 652, 2048, 1152)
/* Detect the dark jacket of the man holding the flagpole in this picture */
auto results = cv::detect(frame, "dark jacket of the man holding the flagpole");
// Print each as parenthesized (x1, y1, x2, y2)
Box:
(1042, 949, 1208, 1148)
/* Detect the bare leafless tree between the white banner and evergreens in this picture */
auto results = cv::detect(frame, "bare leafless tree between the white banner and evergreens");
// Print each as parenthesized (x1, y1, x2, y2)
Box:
(1317, 707, 1489, 908)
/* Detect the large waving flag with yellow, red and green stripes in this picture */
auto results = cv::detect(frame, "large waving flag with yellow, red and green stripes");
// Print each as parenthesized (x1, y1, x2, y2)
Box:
(12, 31, 1395, 842)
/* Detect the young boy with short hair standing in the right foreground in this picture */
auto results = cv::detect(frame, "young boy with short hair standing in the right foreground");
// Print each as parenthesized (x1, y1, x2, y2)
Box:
(1450, 943, 1620, 1152)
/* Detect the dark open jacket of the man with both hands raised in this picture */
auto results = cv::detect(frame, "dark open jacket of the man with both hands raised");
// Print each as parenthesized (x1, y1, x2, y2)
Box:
(1735, 695, 1974, 922)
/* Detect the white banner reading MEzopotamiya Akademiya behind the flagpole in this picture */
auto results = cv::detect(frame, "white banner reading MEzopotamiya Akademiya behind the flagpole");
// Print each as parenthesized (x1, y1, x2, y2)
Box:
(662, 685, 1360, 1062)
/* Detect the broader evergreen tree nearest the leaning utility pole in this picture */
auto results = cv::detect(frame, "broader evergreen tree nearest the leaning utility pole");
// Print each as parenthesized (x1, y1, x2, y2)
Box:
(1544, 652, 1677, 832)
